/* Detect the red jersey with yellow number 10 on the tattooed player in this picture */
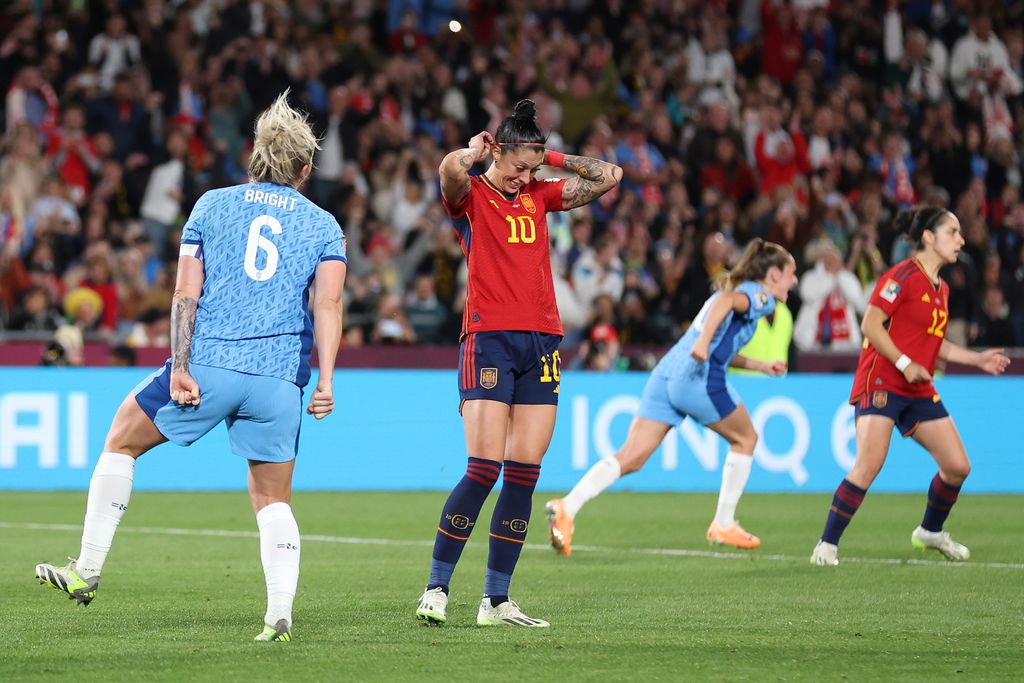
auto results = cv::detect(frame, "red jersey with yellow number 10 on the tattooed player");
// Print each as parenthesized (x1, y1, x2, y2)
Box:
(441, 175, 565, 336)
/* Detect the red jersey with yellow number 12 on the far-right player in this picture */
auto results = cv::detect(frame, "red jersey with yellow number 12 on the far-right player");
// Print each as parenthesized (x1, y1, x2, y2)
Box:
(850, 258, 949, 403)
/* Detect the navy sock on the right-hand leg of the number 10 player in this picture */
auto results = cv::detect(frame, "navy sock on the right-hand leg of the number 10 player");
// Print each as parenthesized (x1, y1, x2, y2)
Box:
(483, 460, 541, 607)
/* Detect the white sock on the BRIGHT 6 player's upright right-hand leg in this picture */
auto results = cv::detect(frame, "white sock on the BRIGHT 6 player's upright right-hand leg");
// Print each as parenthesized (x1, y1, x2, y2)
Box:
(256, 503, 299, 626)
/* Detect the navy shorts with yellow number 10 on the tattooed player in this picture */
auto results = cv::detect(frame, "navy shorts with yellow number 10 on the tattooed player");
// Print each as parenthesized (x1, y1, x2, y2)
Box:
(459, 332, 562, 411)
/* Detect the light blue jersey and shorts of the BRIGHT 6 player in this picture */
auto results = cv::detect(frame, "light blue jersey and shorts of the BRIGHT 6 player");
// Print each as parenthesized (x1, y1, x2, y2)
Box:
(134, 182, 347, 462)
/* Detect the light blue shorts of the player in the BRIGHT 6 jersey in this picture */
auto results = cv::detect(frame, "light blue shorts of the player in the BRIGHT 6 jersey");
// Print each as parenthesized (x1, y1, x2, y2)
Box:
(132, 360, 302, 463)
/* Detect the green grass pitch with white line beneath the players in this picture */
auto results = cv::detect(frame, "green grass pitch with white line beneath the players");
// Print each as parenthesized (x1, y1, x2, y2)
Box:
(0, 492, 1024, 683)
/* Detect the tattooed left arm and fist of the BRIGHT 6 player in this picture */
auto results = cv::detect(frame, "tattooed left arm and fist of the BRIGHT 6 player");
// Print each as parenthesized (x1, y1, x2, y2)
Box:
(170, 256, 205, 405)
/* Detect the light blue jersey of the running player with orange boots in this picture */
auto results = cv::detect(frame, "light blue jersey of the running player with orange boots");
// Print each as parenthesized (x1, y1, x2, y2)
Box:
(654, 281, 775, 377)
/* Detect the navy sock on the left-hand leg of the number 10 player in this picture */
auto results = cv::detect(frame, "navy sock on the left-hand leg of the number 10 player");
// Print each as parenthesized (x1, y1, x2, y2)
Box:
(427, 458, 502, 593)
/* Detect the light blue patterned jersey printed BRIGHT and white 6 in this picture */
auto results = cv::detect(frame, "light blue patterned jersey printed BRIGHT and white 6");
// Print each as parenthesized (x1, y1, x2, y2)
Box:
(181, 182, 347, 387)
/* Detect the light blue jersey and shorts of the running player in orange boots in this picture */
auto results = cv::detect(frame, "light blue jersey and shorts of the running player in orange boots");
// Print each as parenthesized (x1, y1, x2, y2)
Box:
(637, 281, 775, 426)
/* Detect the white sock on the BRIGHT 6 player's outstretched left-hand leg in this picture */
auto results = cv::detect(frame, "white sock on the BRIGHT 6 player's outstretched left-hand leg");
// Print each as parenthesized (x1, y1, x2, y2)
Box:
(75, 453, 135, 577)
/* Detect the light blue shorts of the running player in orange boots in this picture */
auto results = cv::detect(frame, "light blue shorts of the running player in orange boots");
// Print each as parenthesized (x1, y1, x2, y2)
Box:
(637, 364, 740, 427)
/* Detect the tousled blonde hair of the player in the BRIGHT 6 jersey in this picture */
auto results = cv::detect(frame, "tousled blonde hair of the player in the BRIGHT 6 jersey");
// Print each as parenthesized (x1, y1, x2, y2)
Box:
(249, 90, 319, 185)
